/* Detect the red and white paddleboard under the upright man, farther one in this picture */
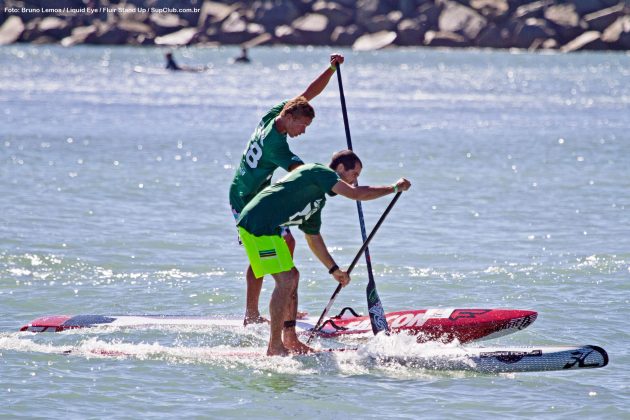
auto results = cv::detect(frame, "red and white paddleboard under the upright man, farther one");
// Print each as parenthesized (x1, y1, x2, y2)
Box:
(20, 308, 538, 343)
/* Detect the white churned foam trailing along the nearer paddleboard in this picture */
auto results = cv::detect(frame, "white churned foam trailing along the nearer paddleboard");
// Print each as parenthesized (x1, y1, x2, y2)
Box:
(0, 328, 488, 377)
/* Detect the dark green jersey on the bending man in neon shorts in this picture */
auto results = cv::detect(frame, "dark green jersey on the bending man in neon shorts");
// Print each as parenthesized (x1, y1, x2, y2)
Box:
(236, 163, 340, 236)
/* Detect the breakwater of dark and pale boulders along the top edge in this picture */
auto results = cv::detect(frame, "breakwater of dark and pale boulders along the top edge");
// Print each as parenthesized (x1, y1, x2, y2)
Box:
(0, 0, 630, 52)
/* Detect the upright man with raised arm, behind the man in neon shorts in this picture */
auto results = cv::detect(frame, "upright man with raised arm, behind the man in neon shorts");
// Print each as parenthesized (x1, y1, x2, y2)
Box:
(230, 54, 343, 325)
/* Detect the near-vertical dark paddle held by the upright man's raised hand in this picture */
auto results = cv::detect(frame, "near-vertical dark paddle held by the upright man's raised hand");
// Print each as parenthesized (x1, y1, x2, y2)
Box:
(337, 63, 389, 335)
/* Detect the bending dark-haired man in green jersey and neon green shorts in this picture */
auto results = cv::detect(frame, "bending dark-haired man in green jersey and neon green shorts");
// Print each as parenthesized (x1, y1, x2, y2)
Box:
(237, 150, 411, 356)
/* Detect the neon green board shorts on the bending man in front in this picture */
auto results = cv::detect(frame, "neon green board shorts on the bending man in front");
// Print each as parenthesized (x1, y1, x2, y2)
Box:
(238, 226, 295, 278)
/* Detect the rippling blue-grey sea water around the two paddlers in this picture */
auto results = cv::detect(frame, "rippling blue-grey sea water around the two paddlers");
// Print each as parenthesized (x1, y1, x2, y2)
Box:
(0, 45, 630, 419)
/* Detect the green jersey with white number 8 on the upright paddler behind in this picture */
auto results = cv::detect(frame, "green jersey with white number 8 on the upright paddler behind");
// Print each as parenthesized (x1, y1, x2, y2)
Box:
(230, 101, 304, 213)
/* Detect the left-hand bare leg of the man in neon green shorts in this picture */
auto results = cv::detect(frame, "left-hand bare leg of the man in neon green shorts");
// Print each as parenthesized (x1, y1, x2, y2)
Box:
(267, 268, 299, 356)
